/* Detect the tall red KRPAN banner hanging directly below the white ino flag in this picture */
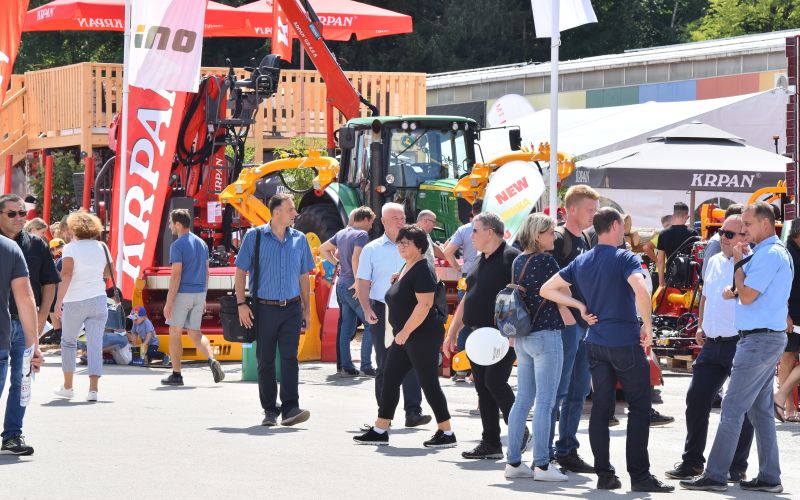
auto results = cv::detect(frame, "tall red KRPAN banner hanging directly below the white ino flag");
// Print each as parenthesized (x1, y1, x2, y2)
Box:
(111, 86, 186, 299)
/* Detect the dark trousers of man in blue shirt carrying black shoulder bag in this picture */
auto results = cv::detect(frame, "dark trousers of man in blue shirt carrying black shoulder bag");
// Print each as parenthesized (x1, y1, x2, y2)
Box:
(256, 301, 303, 415)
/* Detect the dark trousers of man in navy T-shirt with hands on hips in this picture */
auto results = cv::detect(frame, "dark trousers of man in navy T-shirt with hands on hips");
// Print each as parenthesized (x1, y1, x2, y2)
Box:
(585, 342, 651, 483)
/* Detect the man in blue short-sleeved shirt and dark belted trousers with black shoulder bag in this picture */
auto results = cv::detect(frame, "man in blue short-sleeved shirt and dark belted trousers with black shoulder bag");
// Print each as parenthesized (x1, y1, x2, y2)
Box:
(234, 194, 315, 427)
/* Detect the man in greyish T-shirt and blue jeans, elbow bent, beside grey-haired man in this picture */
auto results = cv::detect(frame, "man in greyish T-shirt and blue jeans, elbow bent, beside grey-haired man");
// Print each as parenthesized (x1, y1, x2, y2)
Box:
(319, 207, 376, 377)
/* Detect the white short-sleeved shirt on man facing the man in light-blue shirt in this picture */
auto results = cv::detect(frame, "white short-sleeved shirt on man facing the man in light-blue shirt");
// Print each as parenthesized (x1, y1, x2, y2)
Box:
(702, 252, 738, 337)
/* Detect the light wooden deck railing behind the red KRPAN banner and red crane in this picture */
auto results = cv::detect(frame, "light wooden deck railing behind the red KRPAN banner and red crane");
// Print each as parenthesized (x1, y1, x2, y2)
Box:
(0, 63, 426, 164)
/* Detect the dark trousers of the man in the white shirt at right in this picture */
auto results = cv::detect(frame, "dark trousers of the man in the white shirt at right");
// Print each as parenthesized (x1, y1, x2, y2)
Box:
(682, 340, 753, 472)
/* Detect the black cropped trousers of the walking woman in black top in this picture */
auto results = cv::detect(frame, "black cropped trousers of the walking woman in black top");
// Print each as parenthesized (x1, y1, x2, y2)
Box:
(378, 327, 450, 423)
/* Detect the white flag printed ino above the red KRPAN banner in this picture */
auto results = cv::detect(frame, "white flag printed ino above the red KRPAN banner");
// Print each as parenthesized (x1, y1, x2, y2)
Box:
(128, 0, 208, 92)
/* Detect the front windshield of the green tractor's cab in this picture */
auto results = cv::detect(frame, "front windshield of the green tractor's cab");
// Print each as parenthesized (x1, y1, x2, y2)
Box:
(387, 128, 467, 187)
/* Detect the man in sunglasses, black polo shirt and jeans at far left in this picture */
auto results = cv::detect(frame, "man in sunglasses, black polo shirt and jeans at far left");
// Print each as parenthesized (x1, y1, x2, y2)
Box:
(0, 194, 61, 455)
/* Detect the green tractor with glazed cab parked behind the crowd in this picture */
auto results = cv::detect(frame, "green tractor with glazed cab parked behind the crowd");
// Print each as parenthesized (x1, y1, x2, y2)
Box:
(295, 116, 478, 241)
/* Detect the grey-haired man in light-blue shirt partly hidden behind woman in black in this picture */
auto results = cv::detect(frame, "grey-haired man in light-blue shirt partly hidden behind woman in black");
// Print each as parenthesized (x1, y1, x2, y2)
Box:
(356, 203, 431, 427)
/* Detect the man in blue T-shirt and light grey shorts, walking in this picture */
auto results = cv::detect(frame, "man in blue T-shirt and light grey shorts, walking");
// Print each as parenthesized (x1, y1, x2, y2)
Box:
(161, 208, 225, 385)
